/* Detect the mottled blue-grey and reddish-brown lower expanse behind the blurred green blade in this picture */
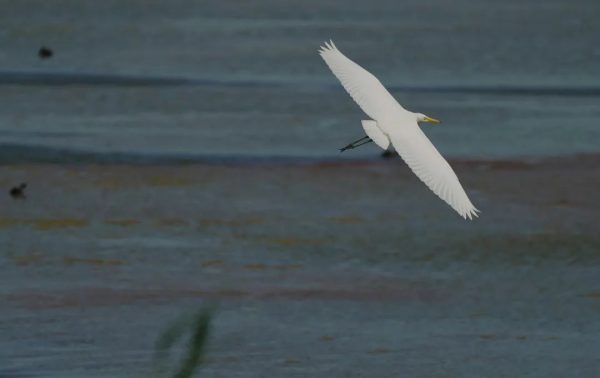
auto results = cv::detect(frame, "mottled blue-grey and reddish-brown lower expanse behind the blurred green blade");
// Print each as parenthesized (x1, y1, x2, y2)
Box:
(0, 155, 600, 377)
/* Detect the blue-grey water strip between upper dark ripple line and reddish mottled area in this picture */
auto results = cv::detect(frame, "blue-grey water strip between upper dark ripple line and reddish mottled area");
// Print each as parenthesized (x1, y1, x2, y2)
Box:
(0, 86, 600, 161)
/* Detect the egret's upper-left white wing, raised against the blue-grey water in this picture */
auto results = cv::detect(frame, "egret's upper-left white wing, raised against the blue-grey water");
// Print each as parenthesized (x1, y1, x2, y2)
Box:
(319, 41, 402, 120)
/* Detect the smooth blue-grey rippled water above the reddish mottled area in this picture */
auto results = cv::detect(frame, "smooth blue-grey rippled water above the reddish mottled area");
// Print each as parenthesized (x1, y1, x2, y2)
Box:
(0, 1, 600, 160)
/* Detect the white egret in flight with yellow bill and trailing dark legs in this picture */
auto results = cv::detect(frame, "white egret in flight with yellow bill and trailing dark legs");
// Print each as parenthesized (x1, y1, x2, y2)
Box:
(319, 41, 479, 219)
